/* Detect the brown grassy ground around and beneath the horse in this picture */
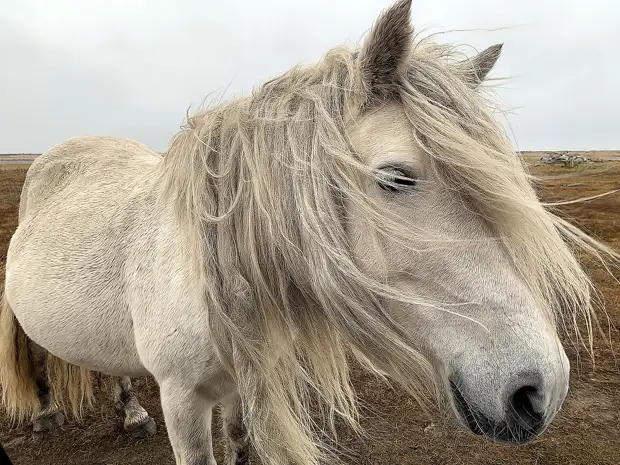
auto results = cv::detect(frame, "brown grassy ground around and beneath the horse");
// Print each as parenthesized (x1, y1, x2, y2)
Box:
(0, 157, 620, 465)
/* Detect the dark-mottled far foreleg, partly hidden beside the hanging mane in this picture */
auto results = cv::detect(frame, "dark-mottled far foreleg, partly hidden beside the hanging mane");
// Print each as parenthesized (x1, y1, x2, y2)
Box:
(222, 392, 250, 465)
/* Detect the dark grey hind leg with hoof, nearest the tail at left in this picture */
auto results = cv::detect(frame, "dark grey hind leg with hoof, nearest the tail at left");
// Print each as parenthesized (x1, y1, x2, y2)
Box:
(28, 340, 65, 433)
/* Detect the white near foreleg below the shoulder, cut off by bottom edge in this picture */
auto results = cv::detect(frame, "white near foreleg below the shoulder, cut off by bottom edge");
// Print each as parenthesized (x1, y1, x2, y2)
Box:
(160, 380, 217, 465)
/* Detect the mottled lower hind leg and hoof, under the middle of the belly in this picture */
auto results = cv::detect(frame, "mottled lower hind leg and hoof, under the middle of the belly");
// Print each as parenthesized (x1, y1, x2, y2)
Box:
(114, 376, 157, 439)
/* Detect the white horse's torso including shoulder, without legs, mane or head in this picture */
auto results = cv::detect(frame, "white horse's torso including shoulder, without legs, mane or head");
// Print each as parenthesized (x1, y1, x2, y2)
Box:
(6, 137, 234, 456)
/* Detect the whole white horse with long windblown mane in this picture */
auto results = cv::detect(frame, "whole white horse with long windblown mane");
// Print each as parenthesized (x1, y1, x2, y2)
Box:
(0, 0, 616, 465)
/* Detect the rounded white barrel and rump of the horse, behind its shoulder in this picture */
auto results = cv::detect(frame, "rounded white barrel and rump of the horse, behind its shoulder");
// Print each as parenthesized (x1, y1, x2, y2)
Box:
(5, 137, 159, 376)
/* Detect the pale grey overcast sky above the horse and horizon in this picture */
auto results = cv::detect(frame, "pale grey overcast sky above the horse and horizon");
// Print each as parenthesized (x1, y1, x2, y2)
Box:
(0, 0, 620, 153)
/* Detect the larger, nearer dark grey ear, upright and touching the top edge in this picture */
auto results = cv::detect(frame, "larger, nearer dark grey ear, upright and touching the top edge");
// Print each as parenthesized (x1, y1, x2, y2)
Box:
(360, 0, 413, 98)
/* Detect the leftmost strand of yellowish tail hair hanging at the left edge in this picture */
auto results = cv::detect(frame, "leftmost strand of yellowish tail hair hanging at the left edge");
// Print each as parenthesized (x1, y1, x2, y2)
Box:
(0, 294, 40, 423)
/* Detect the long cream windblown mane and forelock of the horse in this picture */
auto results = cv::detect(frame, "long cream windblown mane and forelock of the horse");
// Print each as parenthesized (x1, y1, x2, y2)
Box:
(160, 35, 616, 465)
